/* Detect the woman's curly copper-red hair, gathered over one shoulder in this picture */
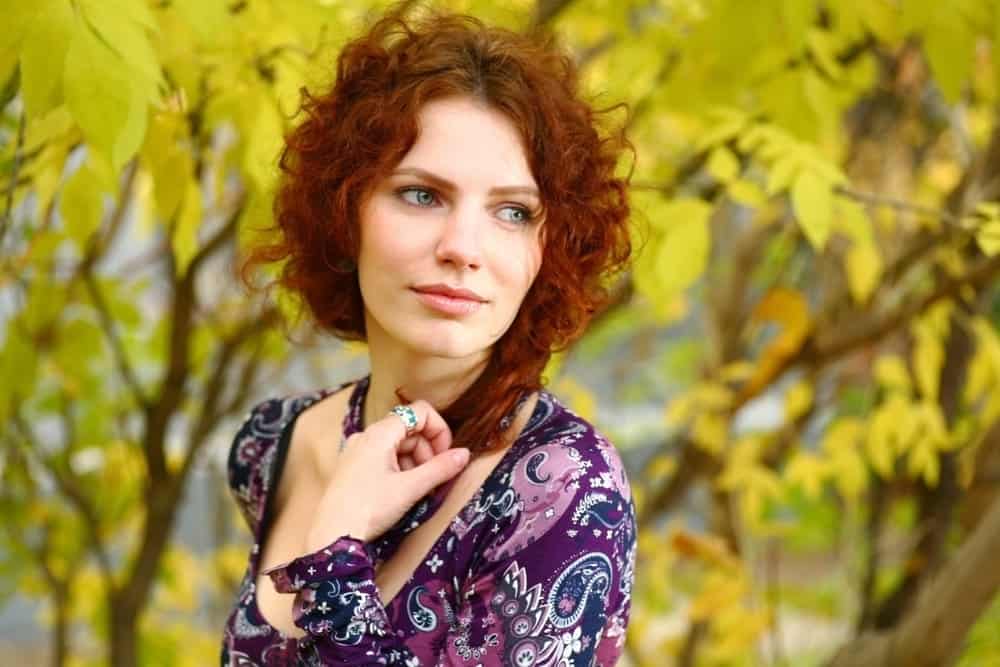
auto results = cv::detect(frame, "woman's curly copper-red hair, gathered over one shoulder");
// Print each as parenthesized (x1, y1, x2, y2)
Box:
(241, 5, 632, 450)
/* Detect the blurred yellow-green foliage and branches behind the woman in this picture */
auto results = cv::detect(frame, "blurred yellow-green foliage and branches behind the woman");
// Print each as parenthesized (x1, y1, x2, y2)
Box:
(0, 0, 1000, 667)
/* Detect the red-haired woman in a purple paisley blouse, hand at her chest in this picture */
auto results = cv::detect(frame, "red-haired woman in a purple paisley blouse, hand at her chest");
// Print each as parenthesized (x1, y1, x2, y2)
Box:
(222, 3, 635, 665)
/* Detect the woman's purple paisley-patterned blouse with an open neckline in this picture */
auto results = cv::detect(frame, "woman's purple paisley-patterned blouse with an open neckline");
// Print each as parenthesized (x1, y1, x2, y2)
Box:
(222, 377, 636, 667)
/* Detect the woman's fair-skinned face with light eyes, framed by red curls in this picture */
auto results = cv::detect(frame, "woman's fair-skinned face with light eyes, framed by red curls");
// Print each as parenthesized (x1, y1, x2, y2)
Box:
(358, 98, 542, 358)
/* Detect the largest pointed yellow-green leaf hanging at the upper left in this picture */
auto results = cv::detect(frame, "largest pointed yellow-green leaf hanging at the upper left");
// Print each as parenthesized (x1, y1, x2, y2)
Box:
(64, 22, 146, 172)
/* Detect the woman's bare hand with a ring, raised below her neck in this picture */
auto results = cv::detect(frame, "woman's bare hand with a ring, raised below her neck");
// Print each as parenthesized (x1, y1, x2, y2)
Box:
(305, 400, 469, 553)
